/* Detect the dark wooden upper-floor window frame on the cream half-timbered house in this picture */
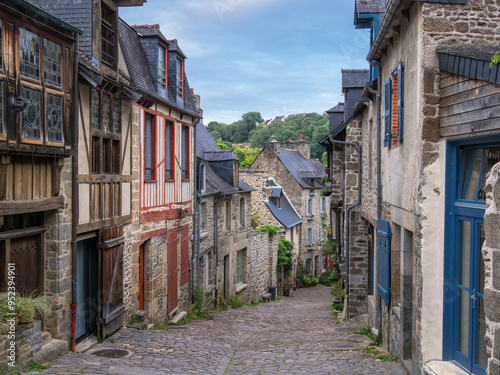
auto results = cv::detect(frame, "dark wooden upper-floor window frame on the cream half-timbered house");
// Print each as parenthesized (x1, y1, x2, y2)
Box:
(89, 87, 122, 175)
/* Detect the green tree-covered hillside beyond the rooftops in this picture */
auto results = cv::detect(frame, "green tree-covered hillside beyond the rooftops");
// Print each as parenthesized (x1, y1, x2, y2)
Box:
(207, 112, 328, 167)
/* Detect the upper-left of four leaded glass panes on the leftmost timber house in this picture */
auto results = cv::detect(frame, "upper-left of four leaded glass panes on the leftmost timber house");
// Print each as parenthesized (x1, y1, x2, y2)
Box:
(19, 28, 40, 79)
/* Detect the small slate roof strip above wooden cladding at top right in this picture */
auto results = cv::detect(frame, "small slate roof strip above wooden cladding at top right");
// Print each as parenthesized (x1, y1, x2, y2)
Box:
(437, 44, 500, 84)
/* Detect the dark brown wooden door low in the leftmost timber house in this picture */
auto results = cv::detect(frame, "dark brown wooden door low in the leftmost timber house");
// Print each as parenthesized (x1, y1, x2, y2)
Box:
(8, 234, 44, 294)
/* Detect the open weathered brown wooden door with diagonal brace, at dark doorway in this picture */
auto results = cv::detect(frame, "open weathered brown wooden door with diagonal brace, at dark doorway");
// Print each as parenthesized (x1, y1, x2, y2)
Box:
(101, 225, 125, 338)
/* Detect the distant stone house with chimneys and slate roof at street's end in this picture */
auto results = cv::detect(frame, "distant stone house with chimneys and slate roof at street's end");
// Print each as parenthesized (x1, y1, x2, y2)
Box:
(250, 134, 330, 277)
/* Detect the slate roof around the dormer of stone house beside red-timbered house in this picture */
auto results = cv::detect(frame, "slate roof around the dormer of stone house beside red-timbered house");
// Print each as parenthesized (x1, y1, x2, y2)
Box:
(195, 123, 255, 195)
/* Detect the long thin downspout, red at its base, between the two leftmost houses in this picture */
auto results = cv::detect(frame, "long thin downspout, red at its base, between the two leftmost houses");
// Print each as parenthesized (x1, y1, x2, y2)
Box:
(71, 34, 80, 352)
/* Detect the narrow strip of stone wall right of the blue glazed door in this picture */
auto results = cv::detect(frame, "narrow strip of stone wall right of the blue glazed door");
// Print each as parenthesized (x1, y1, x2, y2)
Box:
(482, 163, 500, 375)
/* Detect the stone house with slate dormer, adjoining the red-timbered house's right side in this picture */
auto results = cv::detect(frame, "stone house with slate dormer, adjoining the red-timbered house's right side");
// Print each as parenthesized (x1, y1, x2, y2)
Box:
(194, 123, 278, 303)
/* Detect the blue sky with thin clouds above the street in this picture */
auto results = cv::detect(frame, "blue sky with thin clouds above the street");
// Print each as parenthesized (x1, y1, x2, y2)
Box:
(120, 0, 369, 124)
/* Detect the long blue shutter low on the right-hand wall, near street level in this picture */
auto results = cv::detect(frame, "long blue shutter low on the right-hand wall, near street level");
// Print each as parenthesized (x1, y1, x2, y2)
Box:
(377, 219, 391, 306)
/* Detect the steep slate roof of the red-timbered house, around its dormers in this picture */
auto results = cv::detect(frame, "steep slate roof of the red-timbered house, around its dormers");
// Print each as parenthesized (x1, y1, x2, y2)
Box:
(119, 19, 200, 118)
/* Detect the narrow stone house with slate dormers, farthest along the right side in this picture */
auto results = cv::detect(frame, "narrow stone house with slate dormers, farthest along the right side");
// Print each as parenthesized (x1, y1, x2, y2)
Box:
(320, 69, 372, 317)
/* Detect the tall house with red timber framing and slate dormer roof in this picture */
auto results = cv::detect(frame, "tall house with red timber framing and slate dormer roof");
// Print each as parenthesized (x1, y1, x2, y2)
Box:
(120, 20, 201, 322)
